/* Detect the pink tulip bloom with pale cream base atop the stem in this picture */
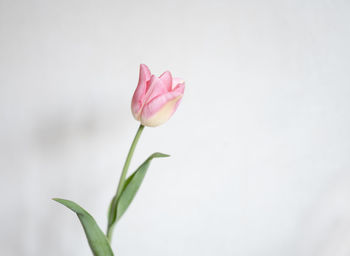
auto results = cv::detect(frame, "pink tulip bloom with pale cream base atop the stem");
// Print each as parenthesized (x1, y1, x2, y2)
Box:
(131, 64, 185, 127)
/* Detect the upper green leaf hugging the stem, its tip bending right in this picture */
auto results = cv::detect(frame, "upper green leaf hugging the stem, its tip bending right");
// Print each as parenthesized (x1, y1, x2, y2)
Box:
(108, 153, 169, 230)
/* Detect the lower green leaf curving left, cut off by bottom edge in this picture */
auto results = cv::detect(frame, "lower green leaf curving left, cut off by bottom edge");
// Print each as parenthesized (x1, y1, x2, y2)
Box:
(53, 198, 113, 256)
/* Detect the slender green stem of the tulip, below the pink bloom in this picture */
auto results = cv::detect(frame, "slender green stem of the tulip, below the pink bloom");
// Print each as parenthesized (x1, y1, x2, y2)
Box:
(107, 124, 144, 242)
